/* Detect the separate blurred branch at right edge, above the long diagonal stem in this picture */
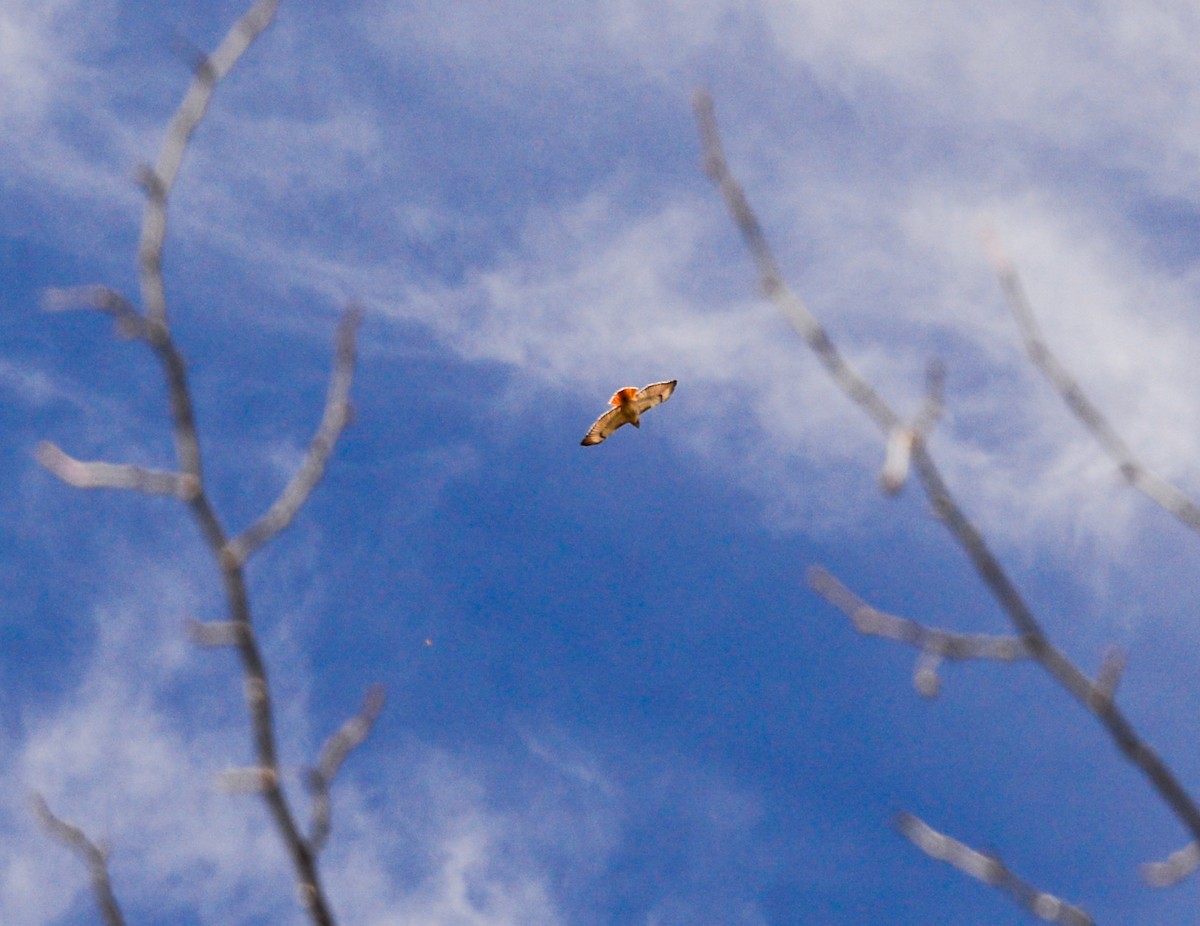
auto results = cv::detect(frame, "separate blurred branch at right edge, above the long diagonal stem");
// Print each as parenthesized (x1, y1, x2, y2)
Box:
(983, 228, 1200, 534)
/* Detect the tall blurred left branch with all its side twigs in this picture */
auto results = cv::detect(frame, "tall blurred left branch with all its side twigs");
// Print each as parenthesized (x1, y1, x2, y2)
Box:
(37, 0, 383, 926)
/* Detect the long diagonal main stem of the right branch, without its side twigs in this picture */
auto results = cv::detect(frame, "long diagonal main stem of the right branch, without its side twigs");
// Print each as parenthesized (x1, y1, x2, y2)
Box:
(694, 90, 1200, 878)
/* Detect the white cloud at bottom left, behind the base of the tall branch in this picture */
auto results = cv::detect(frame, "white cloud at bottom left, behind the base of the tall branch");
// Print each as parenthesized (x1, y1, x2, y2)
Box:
(0, 556, 607, 926)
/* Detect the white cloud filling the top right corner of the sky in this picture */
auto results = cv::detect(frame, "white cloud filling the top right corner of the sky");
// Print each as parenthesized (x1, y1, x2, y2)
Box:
(766, 0, 1200, 198)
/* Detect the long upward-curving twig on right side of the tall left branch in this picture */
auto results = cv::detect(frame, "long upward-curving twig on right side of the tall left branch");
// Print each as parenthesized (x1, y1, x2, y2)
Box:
(223, 307, 362, 564)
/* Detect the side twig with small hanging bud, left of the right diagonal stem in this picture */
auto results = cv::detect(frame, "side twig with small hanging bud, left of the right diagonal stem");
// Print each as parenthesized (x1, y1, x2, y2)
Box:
(809, 566, 1031, 697)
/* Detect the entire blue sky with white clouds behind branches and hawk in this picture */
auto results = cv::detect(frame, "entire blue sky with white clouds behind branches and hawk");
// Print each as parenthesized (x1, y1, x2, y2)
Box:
(7, 0, 1200, 926)
